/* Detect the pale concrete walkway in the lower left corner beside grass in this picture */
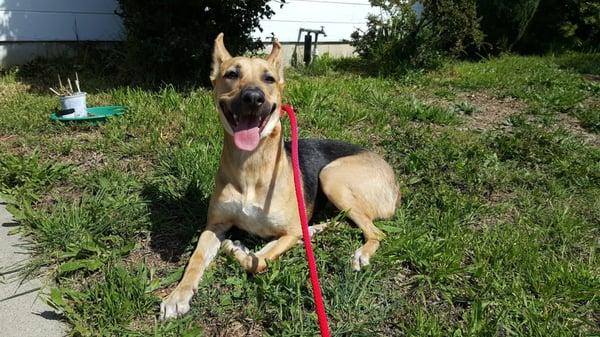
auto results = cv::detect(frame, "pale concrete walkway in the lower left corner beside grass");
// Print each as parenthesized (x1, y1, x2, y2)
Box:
(0, 200, 66, 337)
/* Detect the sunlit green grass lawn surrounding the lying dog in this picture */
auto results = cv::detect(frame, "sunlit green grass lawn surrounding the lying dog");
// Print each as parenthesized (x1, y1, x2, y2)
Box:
(0, 54, 600, 336)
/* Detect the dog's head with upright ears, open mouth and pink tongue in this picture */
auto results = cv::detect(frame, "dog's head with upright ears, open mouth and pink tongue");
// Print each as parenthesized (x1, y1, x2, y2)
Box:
(210, 33, 283, 151)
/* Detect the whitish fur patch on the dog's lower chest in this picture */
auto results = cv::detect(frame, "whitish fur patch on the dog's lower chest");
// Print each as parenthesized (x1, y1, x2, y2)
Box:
(216, 188, 289, 237)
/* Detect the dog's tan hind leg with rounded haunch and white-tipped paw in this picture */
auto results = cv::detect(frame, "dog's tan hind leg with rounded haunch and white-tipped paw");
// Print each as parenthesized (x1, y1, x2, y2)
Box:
(319, 152, 400, 270)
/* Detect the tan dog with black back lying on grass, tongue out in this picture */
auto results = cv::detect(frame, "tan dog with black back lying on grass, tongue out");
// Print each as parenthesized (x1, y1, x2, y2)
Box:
(160, 33, 400, 319)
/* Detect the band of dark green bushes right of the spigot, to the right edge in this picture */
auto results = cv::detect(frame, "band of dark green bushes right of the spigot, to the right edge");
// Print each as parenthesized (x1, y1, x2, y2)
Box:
(352, 0, 600, 61)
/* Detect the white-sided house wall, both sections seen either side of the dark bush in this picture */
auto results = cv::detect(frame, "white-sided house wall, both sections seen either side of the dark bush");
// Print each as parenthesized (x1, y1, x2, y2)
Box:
(0, 0, 373, 65)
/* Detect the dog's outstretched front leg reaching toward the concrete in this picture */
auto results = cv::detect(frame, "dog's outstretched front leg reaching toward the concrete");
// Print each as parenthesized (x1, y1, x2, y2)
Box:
(160, 224, 230, 320)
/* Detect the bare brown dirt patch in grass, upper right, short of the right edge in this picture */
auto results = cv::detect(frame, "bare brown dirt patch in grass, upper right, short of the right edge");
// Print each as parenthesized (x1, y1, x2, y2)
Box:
(457, 92, 526, 130)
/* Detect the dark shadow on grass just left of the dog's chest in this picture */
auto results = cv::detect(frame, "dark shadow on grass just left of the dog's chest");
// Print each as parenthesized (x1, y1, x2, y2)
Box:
(142, 184, 209, 262)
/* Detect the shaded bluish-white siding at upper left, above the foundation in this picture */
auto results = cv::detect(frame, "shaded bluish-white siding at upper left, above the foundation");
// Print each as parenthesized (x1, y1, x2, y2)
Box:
(0, 0, 123, 42)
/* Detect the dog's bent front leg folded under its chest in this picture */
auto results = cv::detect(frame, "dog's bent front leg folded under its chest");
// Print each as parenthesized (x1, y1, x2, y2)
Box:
(222, 235, 298, 273)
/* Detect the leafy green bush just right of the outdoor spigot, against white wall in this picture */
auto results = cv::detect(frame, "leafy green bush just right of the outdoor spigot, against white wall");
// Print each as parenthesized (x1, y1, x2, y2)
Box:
(351, 0, 483, 74)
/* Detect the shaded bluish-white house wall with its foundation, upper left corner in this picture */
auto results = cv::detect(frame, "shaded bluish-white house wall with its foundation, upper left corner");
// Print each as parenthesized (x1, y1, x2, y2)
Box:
(0, 0, 123, 65)
